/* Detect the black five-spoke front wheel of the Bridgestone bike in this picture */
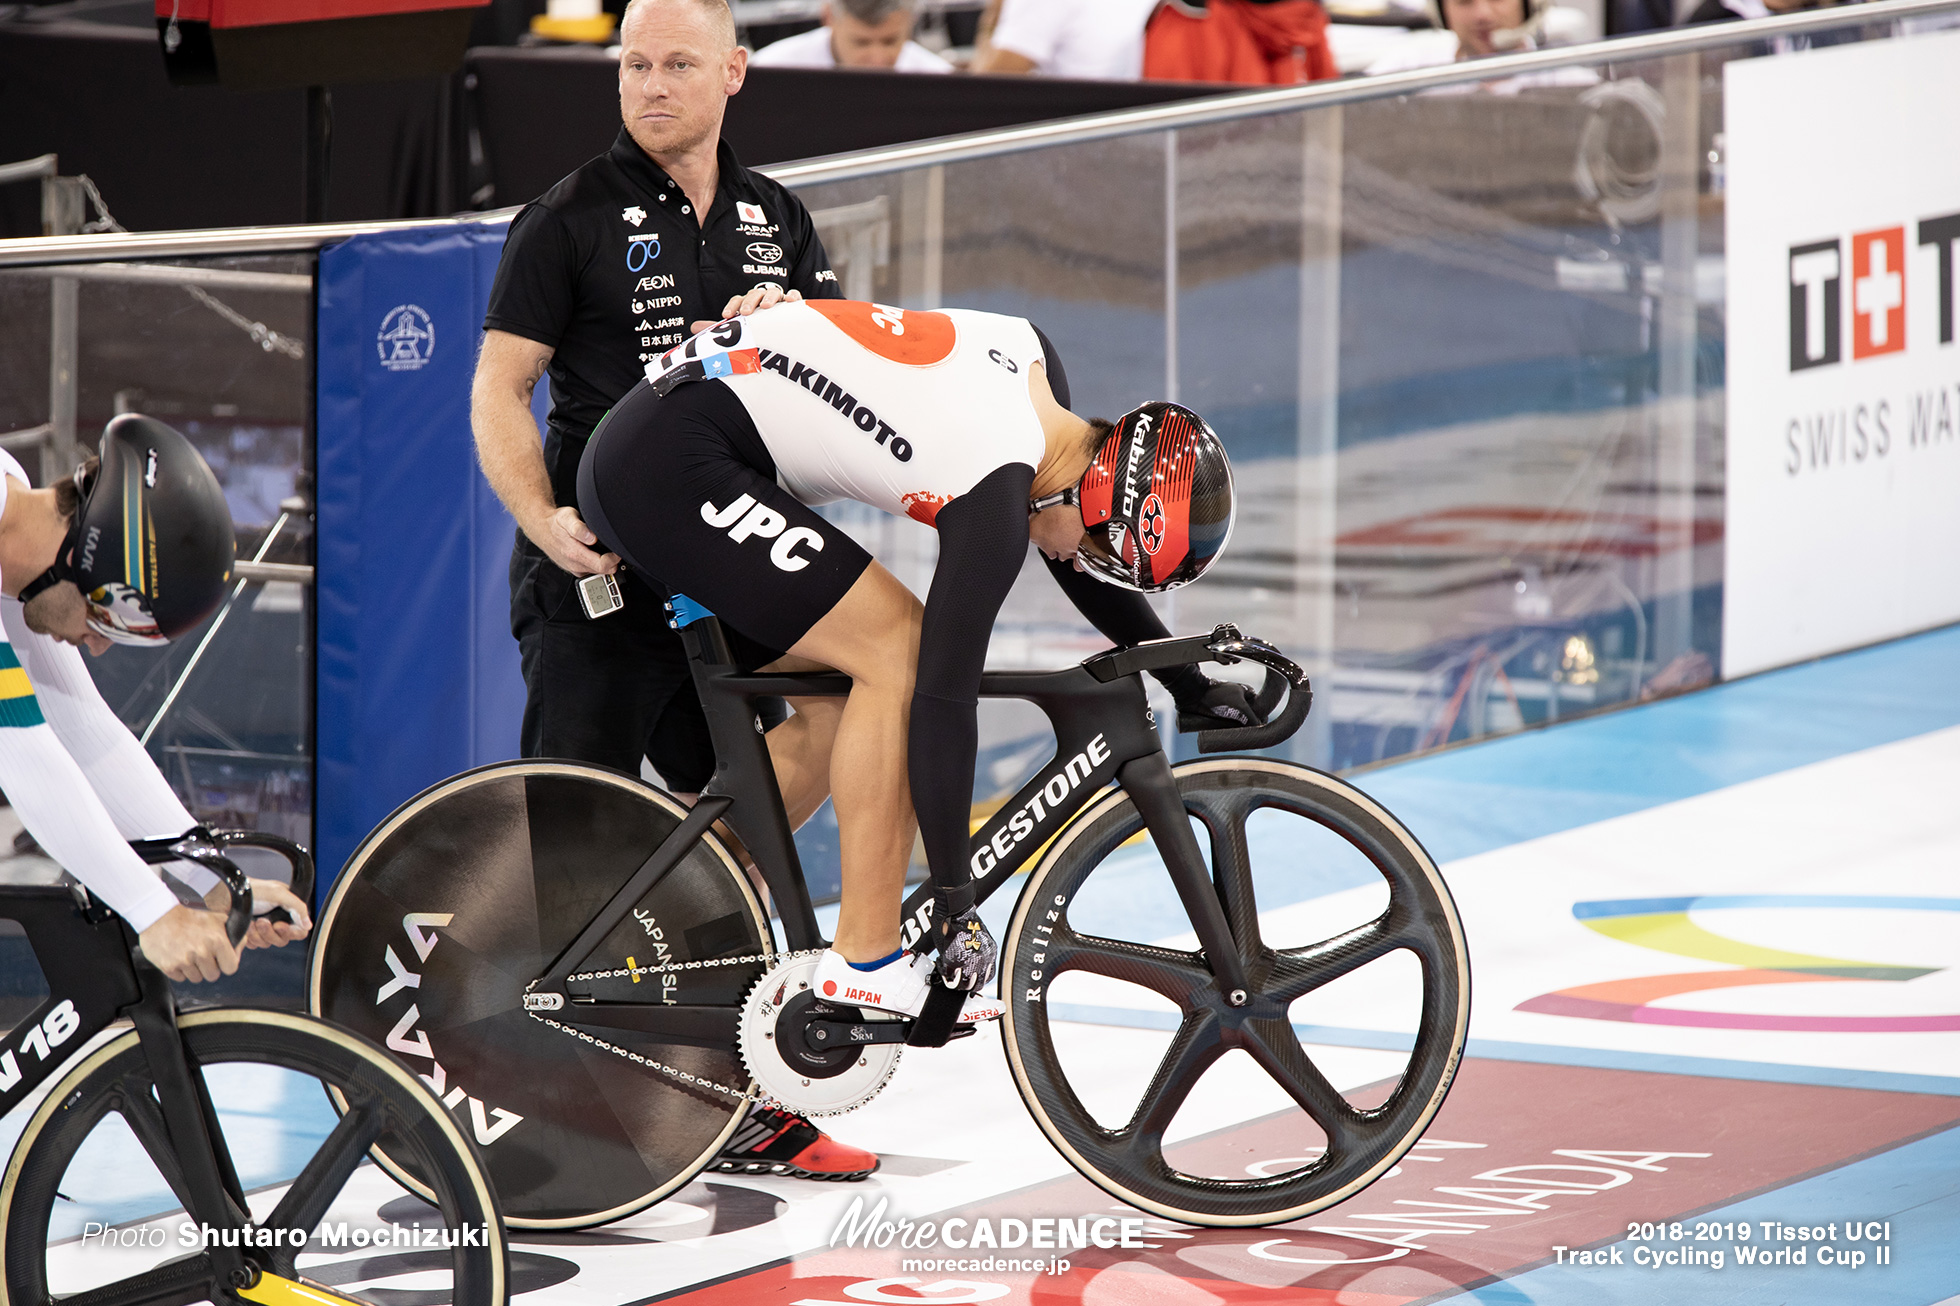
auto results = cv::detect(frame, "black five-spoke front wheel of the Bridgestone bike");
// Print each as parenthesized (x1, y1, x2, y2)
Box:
(1002, 757, 1470, 1228)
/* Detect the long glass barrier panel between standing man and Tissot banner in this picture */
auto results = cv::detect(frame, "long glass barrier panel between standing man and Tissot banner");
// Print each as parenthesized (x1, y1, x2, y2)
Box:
(784, 16, 1952, 820)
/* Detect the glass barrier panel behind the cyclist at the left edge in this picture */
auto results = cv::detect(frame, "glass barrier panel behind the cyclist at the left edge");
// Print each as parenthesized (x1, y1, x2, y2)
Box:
(0, 255, 314, 853)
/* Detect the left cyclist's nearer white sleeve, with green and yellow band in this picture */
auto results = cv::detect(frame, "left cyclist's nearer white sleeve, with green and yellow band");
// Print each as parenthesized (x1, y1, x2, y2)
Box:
(0, 705, 176, 933)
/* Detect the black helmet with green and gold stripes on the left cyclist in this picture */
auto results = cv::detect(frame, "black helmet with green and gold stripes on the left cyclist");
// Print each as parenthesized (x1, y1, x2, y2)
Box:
(22, 414, 235, 645)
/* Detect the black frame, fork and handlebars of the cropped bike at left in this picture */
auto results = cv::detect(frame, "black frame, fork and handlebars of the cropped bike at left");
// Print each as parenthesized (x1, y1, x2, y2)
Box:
(0, 829, 314, 1284)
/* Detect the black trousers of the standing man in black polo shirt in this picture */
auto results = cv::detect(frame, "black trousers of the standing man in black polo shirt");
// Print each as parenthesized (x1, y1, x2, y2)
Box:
(510, 535, 786, 792)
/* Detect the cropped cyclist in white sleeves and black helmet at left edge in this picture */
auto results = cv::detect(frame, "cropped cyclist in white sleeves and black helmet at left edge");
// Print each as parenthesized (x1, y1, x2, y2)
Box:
(0, 416, 308, 980)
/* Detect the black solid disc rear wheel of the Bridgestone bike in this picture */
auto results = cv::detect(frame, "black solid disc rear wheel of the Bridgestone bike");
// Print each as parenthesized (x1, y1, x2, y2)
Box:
(308, 761, 774, 1230)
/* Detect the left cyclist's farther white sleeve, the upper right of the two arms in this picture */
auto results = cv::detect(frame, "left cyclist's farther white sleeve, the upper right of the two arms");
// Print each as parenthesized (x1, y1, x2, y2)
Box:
(0, 598, 218, 896)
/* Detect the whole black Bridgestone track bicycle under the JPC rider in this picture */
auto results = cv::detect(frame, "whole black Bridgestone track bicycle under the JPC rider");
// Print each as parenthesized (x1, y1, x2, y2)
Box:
(308, 616, 1470, 1228)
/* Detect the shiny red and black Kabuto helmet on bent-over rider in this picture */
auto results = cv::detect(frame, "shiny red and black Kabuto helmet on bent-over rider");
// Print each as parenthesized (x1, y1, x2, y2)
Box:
(1076, 400, 1233, 594)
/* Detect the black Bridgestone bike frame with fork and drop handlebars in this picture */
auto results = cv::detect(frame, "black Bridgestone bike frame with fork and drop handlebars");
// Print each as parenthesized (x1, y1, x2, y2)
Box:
(525, 616, 1313, 1047)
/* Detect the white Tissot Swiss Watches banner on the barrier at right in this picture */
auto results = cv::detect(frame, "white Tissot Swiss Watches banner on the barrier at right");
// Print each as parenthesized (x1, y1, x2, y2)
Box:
(1723, 31, 1960, 677)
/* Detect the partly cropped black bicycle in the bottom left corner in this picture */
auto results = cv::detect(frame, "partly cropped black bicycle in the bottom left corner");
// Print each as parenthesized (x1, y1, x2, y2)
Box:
(0, 831, 510, 1306)
